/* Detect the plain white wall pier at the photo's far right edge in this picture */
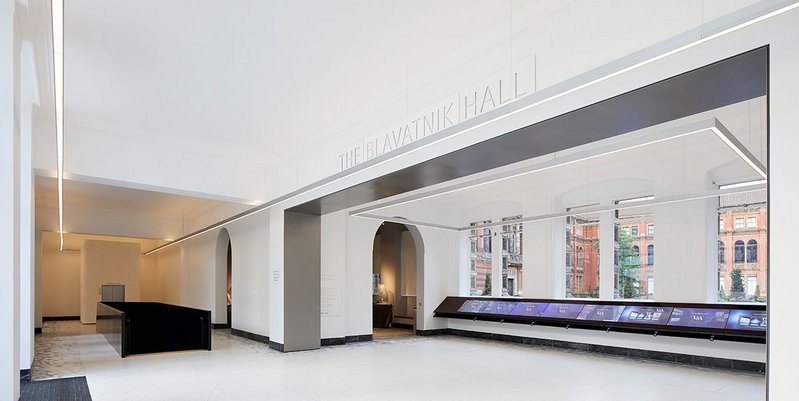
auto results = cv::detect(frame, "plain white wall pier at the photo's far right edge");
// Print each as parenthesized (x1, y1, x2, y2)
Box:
(768, 10, 799, 400)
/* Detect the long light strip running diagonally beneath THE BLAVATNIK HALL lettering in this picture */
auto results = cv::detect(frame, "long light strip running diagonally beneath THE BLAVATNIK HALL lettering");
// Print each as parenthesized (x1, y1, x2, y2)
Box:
(139, 2, 788, 256)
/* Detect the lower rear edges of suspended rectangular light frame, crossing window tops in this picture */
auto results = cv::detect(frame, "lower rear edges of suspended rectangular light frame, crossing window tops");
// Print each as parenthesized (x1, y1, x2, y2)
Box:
(355, 180, 766, 232)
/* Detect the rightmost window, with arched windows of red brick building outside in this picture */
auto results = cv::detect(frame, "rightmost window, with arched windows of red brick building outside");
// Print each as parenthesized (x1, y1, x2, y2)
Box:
(718, 190, 768, 302)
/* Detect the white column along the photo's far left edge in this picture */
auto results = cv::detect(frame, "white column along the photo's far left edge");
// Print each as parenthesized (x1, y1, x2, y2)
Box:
(0, 0, 19, 401)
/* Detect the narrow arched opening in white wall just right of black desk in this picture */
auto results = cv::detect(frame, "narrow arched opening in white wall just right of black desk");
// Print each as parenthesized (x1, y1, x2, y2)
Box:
(213, 228, 233, 328)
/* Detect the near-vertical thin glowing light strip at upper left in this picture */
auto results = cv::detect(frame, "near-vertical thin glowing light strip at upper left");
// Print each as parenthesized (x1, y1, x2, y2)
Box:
(51, 0, 64, 251)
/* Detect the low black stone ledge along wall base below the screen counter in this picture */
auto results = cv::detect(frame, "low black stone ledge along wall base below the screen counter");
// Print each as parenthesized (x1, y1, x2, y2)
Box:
(438, 329, 766, 374)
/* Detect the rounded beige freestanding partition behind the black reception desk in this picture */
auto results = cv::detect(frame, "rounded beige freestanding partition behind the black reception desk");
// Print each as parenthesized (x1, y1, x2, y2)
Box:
(80, 240, 141, 324)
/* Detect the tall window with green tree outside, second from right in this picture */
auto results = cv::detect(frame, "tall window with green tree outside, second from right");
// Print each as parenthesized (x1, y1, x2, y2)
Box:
(613, 207, 655, 299)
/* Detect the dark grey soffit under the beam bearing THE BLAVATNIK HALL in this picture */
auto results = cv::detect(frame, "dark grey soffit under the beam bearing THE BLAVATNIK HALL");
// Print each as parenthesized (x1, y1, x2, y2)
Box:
(289, 47, 768, 215)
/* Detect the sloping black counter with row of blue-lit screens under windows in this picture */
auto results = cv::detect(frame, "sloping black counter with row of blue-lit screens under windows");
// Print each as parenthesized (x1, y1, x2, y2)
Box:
(434, 297, 768, 343)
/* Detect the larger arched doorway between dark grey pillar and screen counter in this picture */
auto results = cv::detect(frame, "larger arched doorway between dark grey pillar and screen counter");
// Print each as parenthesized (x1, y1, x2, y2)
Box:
(372, 222, 424, 339)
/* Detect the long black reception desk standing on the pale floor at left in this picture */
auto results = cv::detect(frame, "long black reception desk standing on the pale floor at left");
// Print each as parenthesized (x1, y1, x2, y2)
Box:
(97, 302, 212, 358)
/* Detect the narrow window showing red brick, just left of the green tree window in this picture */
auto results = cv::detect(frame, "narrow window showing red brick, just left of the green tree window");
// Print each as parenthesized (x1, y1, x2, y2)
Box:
(564, 215, 599, 298)
